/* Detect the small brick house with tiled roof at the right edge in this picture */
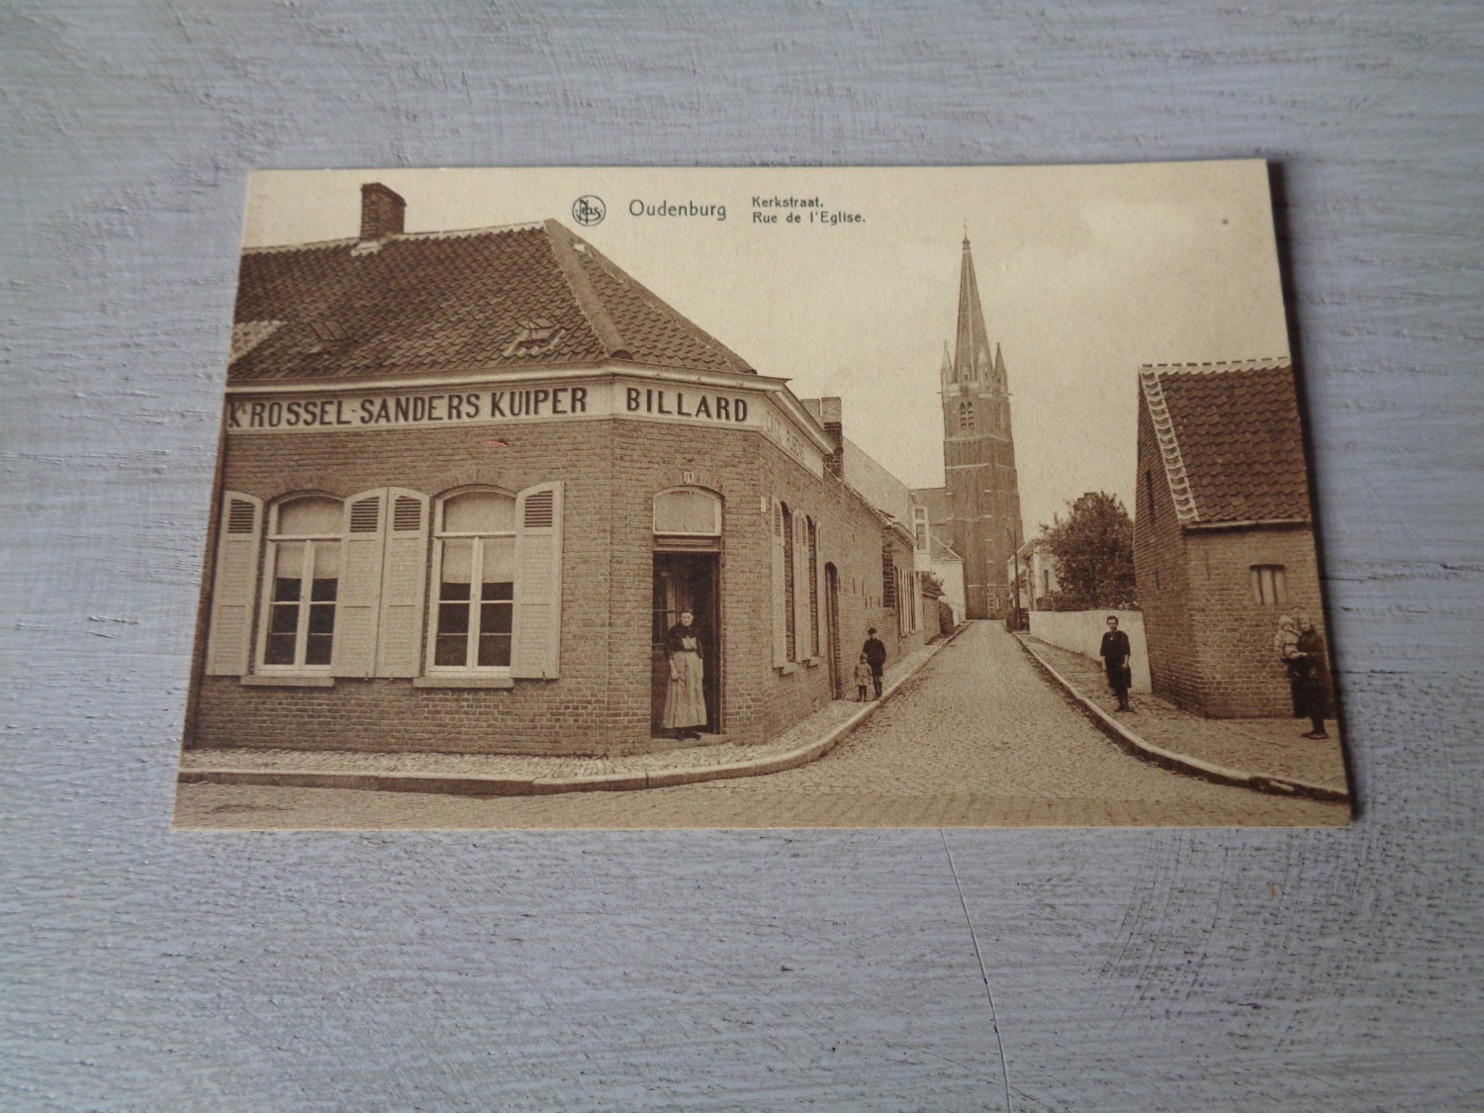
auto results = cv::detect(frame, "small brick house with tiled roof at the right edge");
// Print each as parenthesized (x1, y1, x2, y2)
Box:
(1134, 357, 1324, 718)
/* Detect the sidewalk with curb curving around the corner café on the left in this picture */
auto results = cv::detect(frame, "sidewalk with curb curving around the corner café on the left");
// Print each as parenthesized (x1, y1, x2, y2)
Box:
(180, 626, 963, 795)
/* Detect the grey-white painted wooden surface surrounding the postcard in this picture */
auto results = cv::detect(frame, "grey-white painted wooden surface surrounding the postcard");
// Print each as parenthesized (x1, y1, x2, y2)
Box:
(0, 0, 1484, 1110)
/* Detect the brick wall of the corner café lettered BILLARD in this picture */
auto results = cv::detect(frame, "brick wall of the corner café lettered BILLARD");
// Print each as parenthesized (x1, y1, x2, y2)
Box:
(187, 418, 932, 755)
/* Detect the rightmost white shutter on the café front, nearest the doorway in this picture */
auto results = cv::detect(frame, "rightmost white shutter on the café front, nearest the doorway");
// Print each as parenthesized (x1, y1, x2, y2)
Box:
(510, 481, 562, 679)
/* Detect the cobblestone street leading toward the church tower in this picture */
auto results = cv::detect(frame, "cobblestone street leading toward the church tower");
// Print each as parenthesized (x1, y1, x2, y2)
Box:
(177, 622, 1347, 829)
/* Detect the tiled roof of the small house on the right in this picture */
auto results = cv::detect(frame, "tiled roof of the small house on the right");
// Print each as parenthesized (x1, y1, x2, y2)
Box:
(1140, 359, 1310, 524)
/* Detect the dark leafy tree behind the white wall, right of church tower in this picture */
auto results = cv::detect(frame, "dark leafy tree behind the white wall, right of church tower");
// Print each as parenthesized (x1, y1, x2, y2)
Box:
(1040, 492, 1134, 613)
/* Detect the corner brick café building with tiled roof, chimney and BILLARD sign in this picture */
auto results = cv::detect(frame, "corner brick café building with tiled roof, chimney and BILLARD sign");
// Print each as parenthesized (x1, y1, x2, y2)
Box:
(186, 184, 935, 757)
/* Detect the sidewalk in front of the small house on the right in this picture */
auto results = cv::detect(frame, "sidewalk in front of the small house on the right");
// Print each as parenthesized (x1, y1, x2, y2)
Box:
(1015, 632, 1349, 800)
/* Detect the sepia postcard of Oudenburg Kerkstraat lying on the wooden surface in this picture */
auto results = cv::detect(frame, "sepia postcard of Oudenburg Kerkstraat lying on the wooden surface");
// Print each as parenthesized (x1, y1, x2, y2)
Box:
(175, 160, 1350, 829)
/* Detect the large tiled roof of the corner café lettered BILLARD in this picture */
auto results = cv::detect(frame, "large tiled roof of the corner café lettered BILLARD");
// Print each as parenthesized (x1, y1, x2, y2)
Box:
(229, 221, 754, 383)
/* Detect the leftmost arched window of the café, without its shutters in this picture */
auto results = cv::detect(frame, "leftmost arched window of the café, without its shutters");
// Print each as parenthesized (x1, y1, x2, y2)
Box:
(261, 497, 344, 675)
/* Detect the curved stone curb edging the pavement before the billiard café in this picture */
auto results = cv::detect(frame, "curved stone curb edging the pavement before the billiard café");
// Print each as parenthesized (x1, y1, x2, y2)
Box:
(177, 623, 968, 797)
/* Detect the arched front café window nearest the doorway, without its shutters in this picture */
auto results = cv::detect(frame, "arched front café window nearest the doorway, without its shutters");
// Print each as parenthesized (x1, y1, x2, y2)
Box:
(432, 490, 516, 673)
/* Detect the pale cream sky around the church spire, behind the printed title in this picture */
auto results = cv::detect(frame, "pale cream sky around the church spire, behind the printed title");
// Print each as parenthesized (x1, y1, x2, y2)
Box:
(243, 160, 1290, 538)
